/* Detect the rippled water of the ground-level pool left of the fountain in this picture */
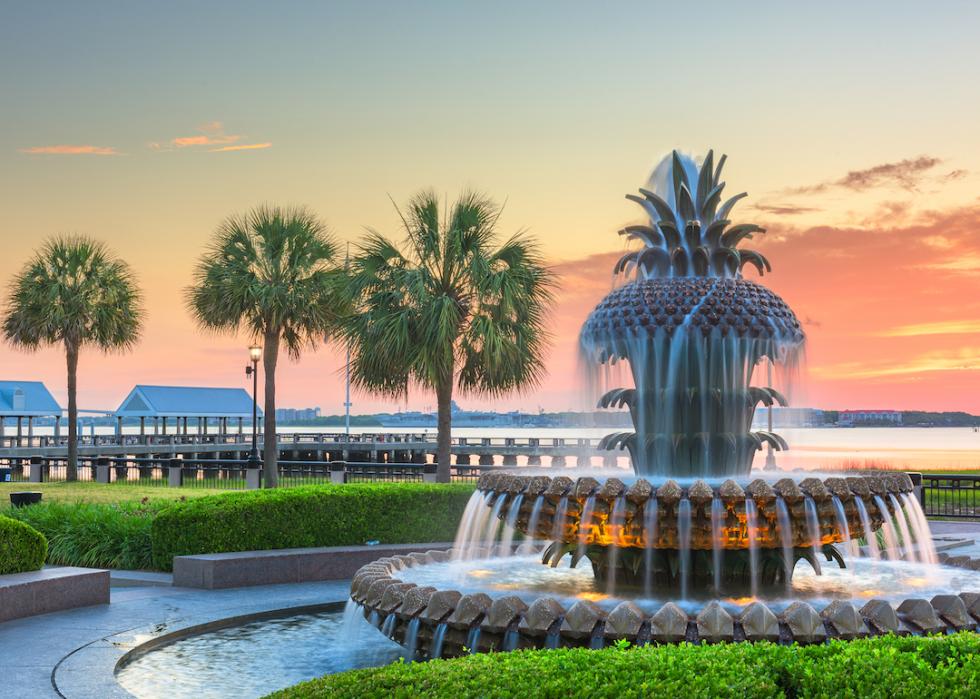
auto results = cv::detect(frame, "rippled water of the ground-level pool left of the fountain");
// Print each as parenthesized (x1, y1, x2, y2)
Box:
(116, 612, 403, 699)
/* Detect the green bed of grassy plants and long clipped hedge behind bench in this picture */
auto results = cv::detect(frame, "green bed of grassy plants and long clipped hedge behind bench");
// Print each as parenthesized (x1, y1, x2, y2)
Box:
(4, 483, 473, 571)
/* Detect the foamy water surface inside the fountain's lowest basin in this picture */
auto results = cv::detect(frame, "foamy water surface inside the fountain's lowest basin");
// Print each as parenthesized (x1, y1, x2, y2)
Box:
(398, 556, 980, 612)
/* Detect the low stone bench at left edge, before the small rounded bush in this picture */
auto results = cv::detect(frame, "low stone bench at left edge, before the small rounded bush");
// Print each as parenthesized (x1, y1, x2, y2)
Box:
(0, 567, 109, 622)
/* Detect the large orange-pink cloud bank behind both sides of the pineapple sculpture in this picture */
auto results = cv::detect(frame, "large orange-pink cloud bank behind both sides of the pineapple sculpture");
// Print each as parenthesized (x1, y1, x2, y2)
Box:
(541, 206, 980, 413)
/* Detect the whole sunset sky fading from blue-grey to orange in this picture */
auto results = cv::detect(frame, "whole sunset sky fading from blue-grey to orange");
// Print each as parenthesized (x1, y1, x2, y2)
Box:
(0, 1, 980, 414)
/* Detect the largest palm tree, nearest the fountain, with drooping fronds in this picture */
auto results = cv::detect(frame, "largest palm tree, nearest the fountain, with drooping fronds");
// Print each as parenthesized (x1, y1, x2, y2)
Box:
(343, 191, 554, 482)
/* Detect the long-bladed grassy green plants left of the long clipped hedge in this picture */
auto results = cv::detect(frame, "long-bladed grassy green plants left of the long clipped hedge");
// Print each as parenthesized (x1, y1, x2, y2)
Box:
(9, 501, 168, 570)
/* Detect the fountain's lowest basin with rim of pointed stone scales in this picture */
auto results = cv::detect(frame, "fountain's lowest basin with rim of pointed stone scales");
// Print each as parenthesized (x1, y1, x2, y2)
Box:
(351, 551, 980, 657)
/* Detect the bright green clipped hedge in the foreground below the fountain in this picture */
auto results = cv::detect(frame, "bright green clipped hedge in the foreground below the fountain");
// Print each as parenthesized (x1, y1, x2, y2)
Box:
(269, 632, 980, 699)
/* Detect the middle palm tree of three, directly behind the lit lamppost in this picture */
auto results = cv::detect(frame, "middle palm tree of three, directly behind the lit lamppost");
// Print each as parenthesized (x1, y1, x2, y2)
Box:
(187, 206, 344, 488)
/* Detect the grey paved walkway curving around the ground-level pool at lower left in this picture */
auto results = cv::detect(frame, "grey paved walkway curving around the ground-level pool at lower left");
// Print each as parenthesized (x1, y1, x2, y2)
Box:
(0, 576, 349, 699)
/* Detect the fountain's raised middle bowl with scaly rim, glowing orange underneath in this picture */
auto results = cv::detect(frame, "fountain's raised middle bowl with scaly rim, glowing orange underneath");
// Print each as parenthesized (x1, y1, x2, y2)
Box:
(478, 473, 914, 551)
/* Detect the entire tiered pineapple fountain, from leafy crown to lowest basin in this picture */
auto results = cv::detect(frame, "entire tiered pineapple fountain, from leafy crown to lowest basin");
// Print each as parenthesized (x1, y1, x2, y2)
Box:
(351, 151, 980, 657)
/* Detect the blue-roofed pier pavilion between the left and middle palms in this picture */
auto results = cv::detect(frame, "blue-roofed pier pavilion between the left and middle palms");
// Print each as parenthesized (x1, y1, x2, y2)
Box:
(114, 384, 262, 435)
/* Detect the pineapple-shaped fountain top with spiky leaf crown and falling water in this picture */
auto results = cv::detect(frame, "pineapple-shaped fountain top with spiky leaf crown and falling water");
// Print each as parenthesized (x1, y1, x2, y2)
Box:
(580, 151, 804, 478)
